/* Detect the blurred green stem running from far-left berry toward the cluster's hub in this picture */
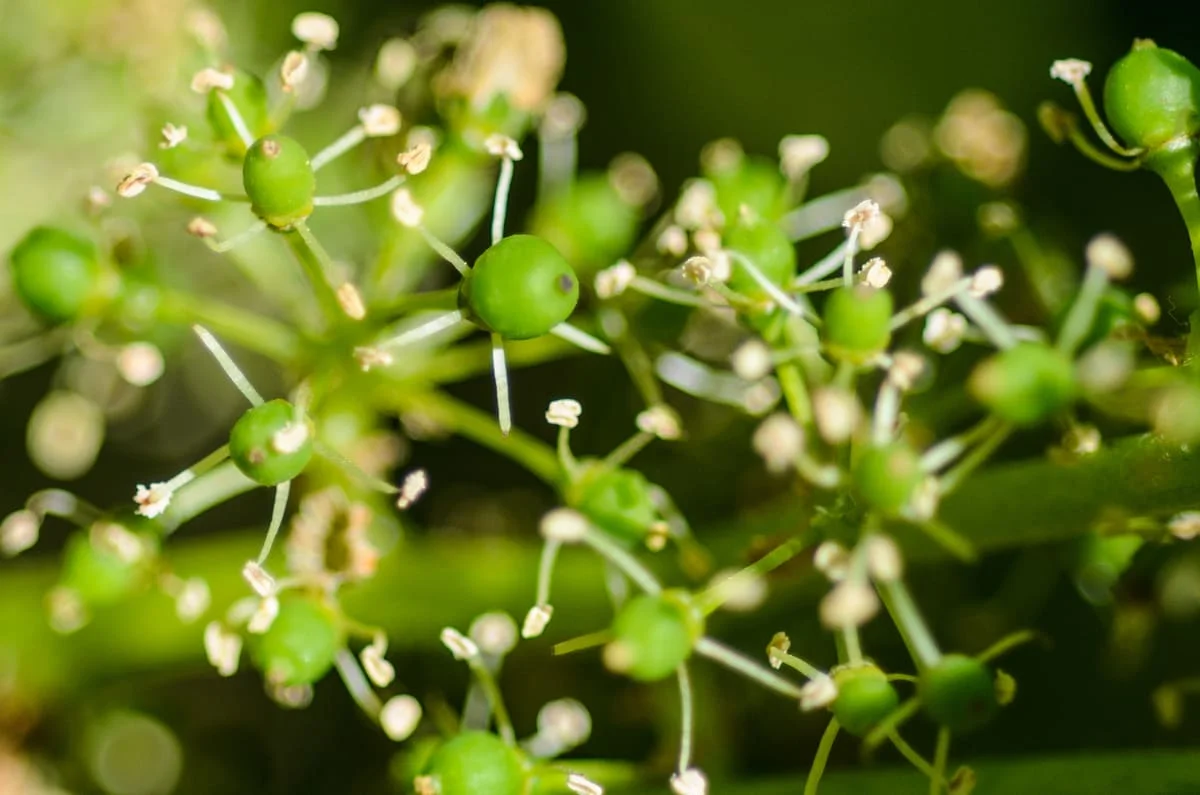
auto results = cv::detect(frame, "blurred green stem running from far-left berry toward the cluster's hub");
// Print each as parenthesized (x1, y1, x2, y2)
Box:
(158, 288, 302, 363)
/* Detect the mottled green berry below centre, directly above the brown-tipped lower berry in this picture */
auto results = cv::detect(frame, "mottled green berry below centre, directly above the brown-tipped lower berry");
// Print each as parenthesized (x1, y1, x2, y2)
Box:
(566, 461, 659, 544)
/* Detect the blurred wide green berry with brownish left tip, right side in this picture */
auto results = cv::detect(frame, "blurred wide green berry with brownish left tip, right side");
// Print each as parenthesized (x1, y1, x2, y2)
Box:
(967, 342, 1075, 425)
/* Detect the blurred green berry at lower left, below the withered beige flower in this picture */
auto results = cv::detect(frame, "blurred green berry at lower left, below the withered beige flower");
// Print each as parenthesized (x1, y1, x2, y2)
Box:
(251, 592, 344, 687)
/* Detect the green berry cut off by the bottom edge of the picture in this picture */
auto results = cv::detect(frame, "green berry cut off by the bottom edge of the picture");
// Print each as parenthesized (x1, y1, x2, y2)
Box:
(425, 731, 529, 795)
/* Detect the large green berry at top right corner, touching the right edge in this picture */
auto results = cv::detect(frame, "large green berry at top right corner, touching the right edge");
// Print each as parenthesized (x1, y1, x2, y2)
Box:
(1104, 38, 1200, 150)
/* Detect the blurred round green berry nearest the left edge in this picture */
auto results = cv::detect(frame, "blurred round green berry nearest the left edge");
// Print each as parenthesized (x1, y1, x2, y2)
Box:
(8, 226, 103, 323)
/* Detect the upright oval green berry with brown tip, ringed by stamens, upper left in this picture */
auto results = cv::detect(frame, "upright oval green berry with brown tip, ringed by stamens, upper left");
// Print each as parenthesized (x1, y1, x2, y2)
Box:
(241, 136, 317, 229)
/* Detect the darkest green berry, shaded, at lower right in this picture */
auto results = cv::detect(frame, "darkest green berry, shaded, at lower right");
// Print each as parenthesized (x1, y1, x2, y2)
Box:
(917, 654, 1000, 733)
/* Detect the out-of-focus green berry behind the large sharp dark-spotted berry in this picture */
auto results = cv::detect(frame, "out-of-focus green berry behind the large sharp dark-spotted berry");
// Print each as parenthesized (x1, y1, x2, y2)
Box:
(530, 174, 640, 274)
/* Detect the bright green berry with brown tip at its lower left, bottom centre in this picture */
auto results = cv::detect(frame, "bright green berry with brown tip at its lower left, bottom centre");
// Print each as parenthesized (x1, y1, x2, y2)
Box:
(605, 591, 704, 682)
